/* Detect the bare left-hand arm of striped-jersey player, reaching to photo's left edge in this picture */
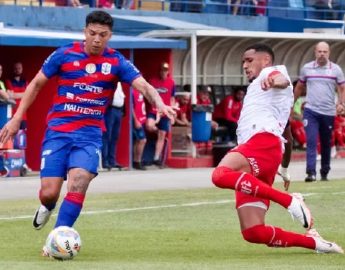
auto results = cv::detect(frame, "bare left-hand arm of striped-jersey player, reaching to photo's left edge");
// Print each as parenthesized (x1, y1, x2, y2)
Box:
(0, 70, 48, 143)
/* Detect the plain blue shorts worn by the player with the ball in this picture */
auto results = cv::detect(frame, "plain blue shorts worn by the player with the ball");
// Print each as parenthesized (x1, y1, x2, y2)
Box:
(40, 130, 102, 179)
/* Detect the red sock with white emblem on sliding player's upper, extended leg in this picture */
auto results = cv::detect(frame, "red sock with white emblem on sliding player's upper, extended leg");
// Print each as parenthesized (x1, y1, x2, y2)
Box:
(212, 166, 292, 208)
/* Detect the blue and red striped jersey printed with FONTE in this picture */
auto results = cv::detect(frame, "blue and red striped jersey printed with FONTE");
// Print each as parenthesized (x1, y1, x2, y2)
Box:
(42, 42, 141, 135)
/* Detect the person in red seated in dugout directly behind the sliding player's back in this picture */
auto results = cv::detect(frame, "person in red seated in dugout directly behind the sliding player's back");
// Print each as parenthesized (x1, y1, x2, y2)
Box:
(213, 88, 245, 142)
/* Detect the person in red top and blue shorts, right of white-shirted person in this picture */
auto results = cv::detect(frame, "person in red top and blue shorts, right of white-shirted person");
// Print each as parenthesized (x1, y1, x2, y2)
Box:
(133, 90, 146, 171)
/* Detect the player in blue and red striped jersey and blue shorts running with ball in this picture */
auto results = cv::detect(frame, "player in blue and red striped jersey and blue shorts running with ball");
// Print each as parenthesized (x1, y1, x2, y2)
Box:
(0, 10, 175, 255)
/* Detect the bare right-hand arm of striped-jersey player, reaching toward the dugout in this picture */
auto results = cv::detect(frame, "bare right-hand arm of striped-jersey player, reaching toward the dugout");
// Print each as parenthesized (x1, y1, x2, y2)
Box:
(132, 77, 176, 120)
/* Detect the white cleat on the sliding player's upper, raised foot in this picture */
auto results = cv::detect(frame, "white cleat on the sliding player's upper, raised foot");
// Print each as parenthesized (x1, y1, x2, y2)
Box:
(288, 193, 313, 229)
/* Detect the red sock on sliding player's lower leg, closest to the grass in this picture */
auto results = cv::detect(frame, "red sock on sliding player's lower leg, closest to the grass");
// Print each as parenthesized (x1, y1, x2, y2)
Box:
(242, 224, 315, 249)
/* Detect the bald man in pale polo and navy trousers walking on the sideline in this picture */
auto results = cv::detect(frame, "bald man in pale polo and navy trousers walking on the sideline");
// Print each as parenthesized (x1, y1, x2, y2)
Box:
(295, 41, 345, 182)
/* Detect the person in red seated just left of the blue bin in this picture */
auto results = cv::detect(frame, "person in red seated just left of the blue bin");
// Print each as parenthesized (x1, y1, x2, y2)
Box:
(175, 92, 191, 126)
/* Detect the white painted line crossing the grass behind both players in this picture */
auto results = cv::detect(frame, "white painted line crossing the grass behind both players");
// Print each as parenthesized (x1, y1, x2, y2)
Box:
(0, 191, 345, 221)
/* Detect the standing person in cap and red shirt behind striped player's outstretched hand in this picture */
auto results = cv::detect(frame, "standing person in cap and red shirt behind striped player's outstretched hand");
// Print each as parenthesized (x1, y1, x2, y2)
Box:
(146, 62, 175, 167)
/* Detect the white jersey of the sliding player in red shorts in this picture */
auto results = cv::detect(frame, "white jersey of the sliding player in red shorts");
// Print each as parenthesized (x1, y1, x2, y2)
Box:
(237, 65, 293, 144)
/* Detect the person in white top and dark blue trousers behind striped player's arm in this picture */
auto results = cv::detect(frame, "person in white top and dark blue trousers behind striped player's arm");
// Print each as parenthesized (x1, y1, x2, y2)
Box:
(102, 82, 126, 171)
